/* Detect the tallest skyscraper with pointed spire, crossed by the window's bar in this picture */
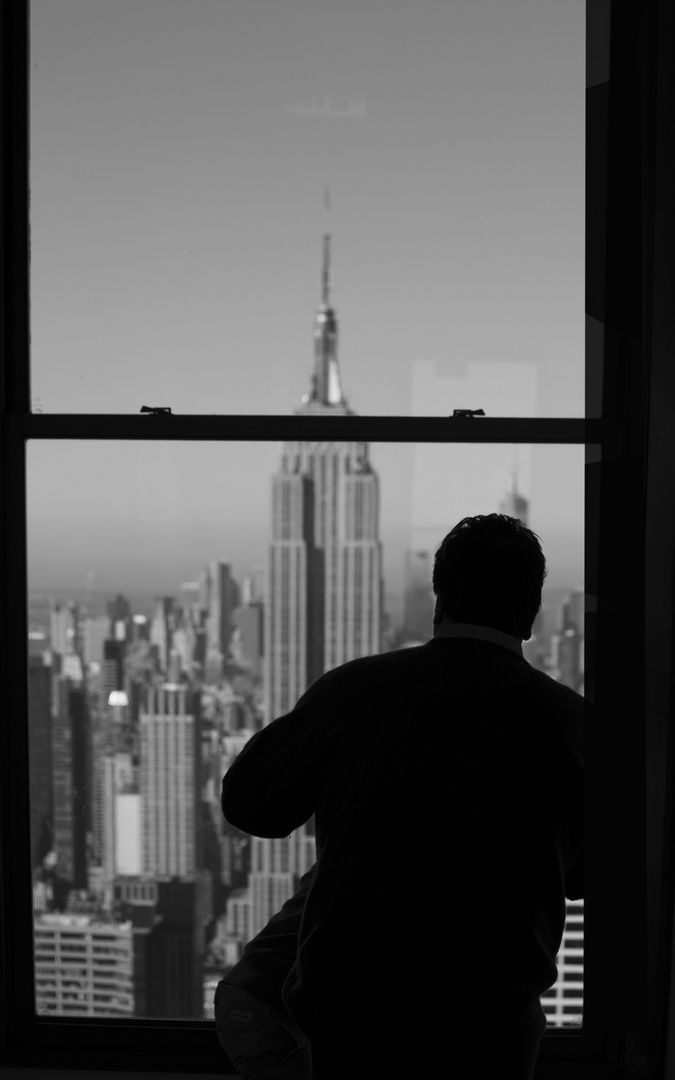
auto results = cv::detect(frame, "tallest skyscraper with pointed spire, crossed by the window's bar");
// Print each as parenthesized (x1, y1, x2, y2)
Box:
(240, 212, 382, 934)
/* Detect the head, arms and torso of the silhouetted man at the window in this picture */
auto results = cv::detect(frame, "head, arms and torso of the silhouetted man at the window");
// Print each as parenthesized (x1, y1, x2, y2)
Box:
(221, 514, 584, 1080)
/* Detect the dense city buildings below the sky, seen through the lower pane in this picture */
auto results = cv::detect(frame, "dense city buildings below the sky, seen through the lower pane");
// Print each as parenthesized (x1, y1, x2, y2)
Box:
(29, 481, 583, 1026)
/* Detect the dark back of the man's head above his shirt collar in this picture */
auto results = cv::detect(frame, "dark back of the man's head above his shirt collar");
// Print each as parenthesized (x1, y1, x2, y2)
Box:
(432, 514, 548, 639)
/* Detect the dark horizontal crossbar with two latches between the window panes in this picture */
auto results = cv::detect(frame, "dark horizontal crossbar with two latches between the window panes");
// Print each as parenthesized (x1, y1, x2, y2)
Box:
(4, 414, 609, 445)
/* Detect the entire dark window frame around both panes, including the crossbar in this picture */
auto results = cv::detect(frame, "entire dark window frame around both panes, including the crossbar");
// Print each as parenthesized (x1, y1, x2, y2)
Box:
(0, 0, 674, 1078)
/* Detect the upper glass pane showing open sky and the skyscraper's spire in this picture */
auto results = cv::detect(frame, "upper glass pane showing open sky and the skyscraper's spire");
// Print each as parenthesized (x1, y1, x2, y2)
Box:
(30, 0, 585, 417)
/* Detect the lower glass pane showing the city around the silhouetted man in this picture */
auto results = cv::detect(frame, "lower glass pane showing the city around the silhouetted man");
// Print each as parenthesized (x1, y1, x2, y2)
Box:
(28, 441, 584, 1026)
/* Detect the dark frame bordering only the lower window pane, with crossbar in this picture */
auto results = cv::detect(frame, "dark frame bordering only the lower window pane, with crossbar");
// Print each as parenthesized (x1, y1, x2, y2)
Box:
(3, 415, 622, 1075)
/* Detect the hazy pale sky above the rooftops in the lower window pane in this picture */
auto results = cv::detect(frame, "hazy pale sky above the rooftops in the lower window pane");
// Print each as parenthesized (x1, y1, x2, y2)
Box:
(27, 436, 584, 603)
